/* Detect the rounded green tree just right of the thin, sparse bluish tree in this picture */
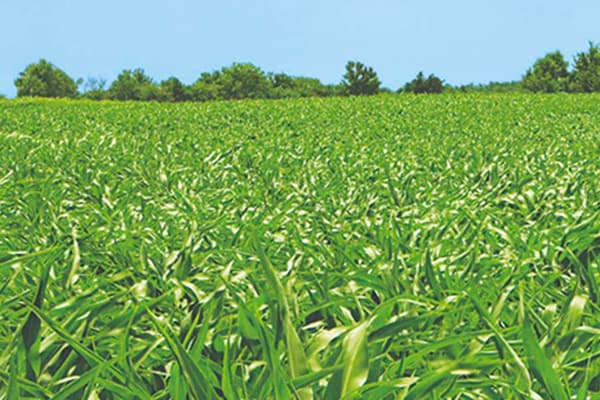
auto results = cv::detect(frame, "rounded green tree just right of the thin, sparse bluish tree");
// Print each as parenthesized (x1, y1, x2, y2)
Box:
(108, 68, 163, 101)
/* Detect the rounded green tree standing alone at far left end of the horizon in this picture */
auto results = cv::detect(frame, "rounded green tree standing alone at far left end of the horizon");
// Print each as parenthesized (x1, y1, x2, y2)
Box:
(15, 60, 77, 97)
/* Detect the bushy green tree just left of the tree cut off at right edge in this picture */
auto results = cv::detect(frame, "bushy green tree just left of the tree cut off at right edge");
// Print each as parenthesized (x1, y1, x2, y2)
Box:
(523, 51, 569, 93)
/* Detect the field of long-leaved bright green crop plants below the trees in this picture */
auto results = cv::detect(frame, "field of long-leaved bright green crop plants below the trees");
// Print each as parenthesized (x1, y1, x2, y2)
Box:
(0, 94, 600, 400)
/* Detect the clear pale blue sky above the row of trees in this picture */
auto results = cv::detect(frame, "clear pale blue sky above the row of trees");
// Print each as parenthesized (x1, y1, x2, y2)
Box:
(0, 0, 600, 96)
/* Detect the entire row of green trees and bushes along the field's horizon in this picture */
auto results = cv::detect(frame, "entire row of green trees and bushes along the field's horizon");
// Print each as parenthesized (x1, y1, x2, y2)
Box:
(5, 43, 600, 102)
